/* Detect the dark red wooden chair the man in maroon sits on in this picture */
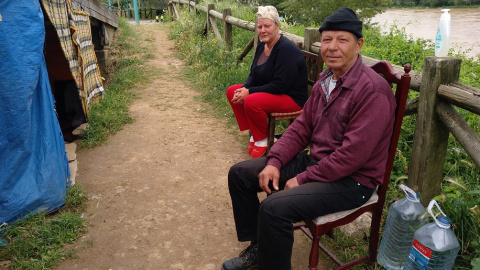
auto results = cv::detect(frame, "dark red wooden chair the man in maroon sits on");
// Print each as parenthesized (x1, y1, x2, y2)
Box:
(294, 61, 411, 270)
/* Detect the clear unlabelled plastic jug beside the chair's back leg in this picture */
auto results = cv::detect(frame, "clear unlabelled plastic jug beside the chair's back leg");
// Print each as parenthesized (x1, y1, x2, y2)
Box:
(377, 184, 425, 270)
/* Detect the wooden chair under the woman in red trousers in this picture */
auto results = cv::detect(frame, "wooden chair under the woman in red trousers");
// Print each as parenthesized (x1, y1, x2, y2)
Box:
(265, 50, 323, 155)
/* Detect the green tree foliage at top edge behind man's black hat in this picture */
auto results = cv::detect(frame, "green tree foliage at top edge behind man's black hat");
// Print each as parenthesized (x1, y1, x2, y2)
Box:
(260, 0, 392, 26)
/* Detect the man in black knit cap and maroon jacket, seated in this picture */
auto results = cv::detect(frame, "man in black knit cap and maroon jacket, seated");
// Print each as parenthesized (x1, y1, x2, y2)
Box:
(222, 8, 396, 270)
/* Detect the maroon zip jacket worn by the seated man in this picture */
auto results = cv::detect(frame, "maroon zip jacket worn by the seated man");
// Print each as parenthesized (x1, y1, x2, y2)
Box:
(267, 56, 396, 188)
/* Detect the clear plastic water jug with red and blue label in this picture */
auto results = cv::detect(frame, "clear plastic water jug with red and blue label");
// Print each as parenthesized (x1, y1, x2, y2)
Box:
(403, 200, 460, 270)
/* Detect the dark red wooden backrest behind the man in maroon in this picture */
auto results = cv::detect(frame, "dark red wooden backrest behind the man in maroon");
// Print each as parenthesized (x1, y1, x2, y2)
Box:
(371, 60, 412, 211)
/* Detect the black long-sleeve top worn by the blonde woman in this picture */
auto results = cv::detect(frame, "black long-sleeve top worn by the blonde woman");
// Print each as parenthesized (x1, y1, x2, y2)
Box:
(243, 35, 308, 107)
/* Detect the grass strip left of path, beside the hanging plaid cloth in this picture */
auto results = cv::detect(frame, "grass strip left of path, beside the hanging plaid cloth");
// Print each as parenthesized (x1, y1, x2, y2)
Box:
(80, 19, 154, 148)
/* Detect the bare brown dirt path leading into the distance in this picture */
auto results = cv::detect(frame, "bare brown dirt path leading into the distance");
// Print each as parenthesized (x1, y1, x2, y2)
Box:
(56, 21, 316, 270)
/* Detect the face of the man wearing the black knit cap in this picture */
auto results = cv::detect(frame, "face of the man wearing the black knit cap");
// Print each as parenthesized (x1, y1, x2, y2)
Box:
(320, 31, 363, 79)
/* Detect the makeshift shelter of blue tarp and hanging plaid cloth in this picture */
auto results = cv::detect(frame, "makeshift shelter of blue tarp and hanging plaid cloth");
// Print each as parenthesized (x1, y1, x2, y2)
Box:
(0, 0, 104, 225)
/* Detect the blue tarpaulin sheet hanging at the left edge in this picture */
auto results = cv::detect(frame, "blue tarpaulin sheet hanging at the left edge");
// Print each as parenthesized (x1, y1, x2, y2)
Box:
(0, 0, 70, 224)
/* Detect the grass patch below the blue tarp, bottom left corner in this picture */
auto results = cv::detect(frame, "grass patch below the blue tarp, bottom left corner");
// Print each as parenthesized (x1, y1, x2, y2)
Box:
(0, 184, 87, 269)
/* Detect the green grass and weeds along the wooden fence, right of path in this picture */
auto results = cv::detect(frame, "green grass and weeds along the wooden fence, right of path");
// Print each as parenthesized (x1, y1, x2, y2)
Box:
(166, 1, 480, 269)
